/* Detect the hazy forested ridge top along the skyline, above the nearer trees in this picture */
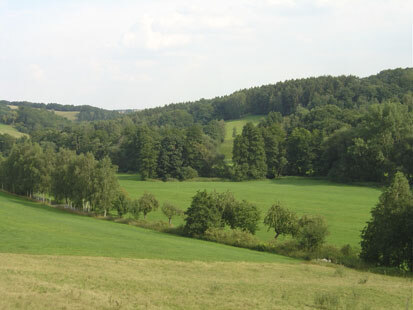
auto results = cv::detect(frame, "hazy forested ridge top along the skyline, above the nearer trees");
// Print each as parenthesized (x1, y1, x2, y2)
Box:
(129, 68, 413, 125)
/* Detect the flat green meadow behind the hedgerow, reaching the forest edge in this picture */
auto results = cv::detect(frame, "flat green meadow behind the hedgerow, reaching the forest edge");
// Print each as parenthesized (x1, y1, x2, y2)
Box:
(119, 174, 380, 246)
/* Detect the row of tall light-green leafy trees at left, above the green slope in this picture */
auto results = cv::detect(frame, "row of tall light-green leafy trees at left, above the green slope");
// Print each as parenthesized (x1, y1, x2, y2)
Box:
(0, 140, 118, 215)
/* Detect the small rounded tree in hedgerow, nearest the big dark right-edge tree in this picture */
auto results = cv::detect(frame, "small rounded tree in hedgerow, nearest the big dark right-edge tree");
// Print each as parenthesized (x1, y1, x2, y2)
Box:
(296, 215, 329, 250)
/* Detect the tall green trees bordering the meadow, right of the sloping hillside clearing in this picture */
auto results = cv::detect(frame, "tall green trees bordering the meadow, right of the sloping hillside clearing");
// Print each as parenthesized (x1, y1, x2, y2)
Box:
(232, 102, 413, 182)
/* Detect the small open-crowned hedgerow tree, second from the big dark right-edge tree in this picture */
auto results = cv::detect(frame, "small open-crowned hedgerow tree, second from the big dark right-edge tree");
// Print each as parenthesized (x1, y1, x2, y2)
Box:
(264, 202, 297, 239)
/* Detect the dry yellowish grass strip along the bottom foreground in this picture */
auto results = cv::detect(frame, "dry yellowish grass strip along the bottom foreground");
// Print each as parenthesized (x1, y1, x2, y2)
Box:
(0, 254, 412, 310)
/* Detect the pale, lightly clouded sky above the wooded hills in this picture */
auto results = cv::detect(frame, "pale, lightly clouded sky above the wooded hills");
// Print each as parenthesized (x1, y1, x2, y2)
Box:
(0, 0, 413, 109)
